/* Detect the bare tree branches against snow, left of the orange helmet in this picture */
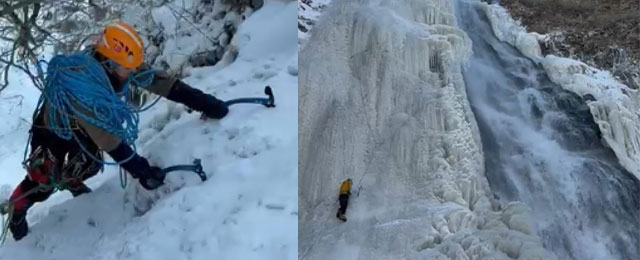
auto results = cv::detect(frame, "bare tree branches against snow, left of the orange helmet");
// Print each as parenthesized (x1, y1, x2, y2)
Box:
(0, 0, 168, 91)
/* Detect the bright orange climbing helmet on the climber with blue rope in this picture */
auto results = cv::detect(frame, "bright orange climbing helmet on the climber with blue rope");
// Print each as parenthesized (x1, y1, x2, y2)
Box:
(96, 21, 144, 69)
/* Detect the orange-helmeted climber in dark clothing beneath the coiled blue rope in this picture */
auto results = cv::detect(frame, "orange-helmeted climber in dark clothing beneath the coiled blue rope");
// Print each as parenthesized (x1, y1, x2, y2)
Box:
(9, 21, 229, 241)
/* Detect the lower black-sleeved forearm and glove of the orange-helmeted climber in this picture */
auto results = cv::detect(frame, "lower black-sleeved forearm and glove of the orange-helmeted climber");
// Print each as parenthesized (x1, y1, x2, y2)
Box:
(109, 142, 165, 190)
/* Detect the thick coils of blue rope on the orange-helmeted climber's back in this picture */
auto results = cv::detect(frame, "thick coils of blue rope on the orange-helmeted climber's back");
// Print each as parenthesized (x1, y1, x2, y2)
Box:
(39, 51, 157, 165)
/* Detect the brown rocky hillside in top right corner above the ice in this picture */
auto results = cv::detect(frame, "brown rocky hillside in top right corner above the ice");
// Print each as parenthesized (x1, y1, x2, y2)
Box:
(500, 0, 640, 89)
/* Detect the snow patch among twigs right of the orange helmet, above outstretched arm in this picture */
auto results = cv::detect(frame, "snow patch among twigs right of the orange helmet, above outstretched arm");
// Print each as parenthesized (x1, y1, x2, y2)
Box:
(145, 0, 255, 71)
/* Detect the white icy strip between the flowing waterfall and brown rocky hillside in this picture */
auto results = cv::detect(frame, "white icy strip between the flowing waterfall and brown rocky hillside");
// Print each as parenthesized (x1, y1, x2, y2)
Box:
(480, 0, 640, 183)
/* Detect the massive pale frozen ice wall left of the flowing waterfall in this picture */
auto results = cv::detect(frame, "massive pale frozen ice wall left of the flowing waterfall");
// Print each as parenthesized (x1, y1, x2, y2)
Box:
(298, 0, 547, 259)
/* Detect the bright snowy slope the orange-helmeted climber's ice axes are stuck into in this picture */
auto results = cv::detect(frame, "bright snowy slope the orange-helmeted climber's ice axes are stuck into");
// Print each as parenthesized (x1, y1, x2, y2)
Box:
(0, 1, 298, 260)
